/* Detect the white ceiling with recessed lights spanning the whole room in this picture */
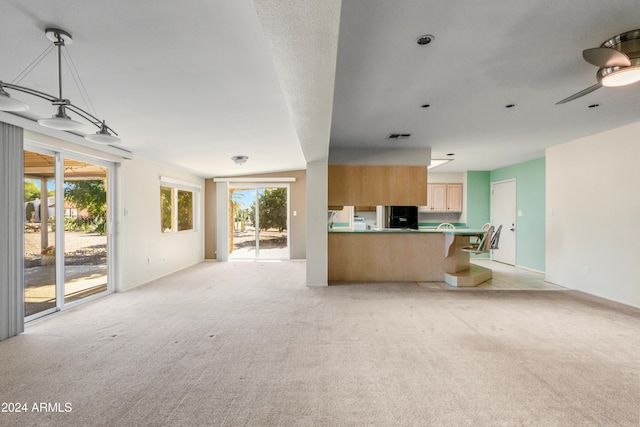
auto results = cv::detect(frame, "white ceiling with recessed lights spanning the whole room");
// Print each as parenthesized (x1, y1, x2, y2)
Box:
(0, 0, 640, 177)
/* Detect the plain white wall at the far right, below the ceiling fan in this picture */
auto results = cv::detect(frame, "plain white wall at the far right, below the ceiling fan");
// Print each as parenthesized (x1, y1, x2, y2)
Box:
(546, 122, 640, 307)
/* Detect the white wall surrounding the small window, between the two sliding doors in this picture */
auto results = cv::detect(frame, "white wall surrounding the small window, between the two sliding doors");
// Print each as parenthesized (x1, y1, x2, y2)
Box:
(116, 158, 204, 291)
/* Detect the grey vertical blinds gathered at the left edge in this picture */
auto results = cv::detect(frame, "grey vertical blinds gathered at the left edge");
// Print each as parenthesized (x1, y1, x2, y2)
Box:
(0, 122, 24, 340)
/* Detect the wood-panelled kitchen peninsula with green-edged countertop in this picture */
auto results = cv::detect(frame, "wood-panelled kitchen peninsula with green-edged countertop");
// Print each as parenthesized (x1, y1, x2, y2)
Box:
(328, 229, 491, 286)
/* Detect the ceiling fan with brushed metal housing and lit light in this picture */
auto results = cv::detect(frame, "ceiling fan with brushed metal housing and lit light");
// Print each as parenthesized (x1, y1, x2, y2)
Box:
(556, 29, 640, 105)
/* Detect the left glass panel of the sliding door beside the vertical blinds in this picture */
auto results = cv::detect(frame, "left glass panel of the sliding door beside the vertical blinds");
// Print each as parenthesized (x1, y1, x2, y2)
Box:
(24, 150, 56, 318)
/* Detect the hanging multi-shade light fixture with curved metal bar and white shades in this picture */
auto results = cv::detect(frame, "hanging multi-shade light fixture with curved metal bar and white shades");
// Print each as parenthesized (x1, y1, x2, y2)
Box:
(0, 28, 120, 144)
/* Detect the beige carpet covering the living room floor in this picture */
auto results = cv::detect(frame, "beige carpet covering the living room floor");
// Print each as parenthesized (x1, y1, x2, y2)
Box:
(0, 262, 640, 426)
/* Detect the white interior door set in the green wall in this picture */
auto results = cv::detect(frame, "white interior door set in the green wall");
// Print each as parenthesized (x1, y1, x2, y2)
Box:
(491, 180, 516, 265)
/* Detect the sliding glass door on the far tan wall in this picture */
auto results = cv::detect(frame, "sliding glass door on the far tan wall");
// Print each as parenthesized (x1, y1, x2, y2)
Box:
(229, 186, 289, 259)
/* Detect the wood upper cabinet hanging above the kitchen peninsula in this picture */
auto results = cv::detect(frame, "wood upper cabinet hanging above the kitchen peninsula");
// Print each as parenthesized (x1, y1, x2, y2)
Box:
(328, 165, 427, 206)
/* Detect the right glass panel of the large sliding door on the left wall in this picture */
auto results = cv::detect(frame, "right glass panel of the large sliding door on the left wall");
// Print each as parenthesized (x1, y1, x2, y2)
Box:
(64, 159, 109, 304)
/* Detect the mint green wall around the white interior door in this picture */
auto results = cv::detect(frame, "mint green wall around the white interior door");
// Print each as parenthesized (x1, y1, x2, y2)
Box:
(490, 157, 546, 271)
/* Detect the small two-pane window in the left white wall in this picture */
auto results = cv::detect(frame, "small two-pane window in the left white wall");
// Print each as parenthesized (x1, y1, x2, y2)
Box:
(160, 178, 198, 233)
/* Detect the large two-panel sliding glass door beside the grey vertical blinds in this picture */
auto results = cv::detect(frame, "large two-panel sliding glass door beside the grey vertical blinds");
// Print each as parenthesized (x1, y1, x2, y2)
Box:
(24, 148, 112, 320)
